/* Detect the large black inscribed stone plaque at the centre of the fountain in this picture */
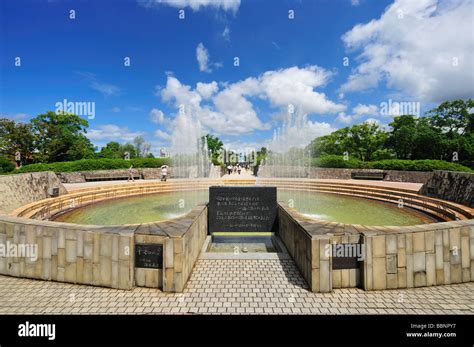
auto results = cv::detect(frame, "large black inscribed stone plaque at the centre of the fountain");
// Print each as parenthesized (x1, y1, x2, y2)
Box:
(208, 186, 277, 233)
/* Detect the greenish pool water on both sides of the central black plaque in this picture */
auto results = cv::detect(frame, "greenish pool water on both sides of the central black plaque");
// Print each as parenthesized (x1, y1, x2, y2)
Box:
(54, 190, 433, 226)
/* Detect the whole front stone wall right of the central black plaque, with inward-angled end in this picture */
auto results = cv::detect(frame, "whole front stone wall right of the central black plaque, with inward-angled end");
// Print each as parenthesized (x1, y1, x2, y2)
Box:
(279, 205, 474, 292)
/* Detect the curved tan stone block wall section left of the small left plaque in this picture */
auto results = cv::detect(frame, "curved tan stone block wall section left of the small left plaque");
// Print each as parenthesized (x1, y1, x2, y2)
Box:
(0, 216, 133, 289)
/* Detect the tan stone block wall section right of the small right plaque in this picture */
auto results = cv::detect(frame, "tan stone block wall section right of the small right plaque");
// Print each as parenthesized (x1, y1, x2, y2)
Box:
(363, 220, 474, 290)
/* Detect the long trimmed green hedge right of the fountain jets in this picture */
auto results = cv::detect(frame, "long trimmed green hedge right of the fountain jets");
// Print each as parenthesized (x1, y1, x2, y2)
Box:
(312, 155, 474, 172)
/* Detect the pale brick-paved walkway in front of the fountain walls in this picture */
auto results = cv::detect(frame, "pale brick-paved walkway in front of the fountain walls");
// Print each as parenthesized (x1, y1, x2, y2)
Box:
(0, 259, 474, 314)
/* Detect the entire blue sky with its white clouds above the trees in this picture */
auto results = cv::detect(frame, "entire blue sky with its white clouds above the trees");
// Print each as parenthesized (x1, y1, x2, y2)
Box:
(0, 0, 474, 153)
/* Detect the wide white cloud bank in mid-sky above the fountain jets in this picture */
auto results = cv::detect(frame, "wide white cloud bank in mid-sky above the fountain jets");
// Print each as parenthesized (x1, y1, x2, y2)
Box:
(157, 66, 346, 135)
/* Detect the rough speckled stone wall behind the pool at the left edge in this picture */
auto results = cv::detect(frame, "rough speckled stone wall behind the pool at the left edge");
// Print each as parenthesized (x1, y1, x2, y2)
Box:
(0, 172, 67, 214)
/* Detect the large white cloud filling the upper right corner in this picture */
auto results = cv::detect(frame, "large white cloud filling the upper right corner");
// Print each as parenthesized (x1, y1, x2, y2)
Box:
(341, 0, 474, 102)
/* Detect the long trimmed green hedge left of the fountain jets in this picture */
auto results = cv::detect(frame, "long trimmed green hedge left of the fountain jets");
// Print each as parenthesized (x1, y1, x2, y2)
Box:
(15, 158, 171, 173)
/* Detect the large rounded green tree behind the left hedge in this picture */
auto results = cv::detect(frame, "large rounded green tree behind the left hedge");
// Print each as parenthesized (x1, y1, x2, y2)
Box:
(31, 111, 95, 163)
